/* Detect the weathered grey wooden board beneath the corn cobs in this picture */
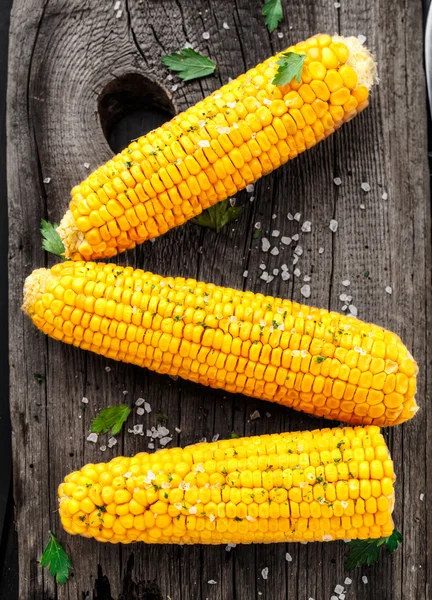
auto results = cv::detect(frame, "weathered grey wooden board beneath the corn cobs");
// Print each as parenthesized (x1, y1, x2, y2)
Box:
(7, 0, 432, 600)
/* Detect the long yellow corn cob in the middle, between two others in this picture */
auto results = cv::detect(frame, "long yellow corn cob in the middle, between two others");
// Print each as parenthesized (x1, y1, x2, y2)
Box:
(23, 262, 417, 425)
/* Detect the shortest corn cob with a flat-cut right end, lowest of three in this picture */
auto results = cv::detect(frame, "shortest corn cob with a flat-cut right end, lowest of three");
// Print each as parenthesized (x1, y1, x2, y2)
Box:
(58, 426, 395, 544)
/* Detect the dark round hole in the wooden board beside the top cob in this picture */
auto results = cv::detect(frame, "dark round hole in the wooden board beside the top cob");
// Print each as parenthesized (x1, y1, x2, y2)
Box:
(98, 73, 176, 152)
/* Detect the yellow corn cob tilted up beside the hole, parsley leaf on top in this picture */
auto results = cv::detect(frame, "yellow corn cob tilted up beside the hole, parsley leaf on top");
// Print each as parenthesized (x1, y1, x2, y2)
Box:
(58, 35, 376, 260)
